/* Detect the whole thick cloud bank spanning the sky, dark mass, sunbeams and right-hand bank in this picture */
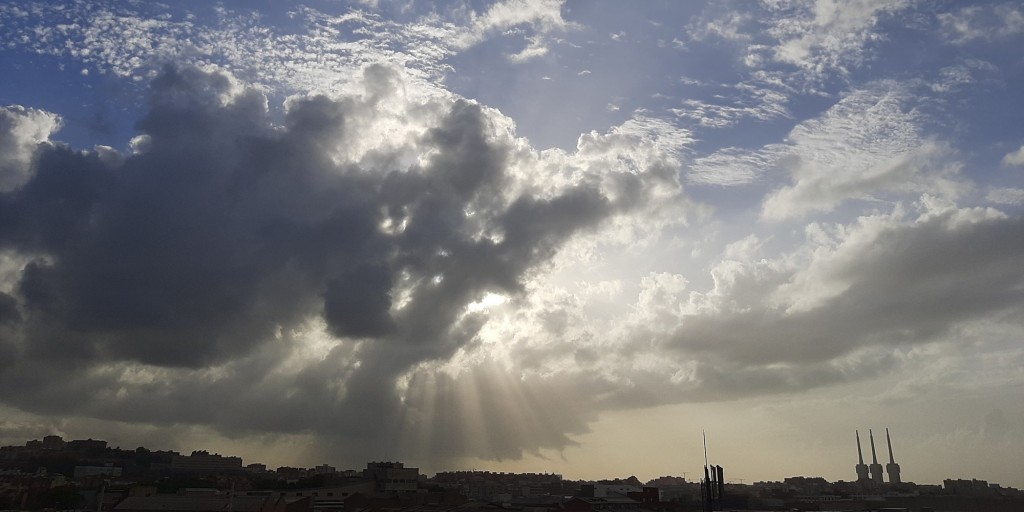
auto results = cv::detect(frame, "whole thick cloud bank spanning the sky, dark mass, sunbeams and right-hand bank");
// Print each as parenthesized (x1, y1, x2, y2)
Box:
(0, 61, 1024, 466)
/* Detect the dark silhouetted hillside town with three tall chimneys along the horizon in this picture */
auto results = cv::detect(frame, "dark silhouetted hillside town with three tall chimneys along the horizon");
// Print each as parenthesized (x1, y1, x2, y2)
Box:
(0, 435, 1024, 512)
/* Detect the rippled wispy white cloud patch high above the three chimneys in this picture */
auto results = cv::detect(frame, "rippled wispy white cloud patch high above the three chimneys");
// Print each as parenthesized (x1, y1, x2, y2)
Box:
(762, 83, 967, 219)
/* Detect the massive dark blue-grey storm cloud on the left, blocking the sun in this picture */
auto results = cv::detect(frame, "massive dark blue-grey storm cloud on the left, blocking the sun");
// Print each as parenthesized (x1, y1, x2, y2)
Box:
(0, 61, 659, 457)
